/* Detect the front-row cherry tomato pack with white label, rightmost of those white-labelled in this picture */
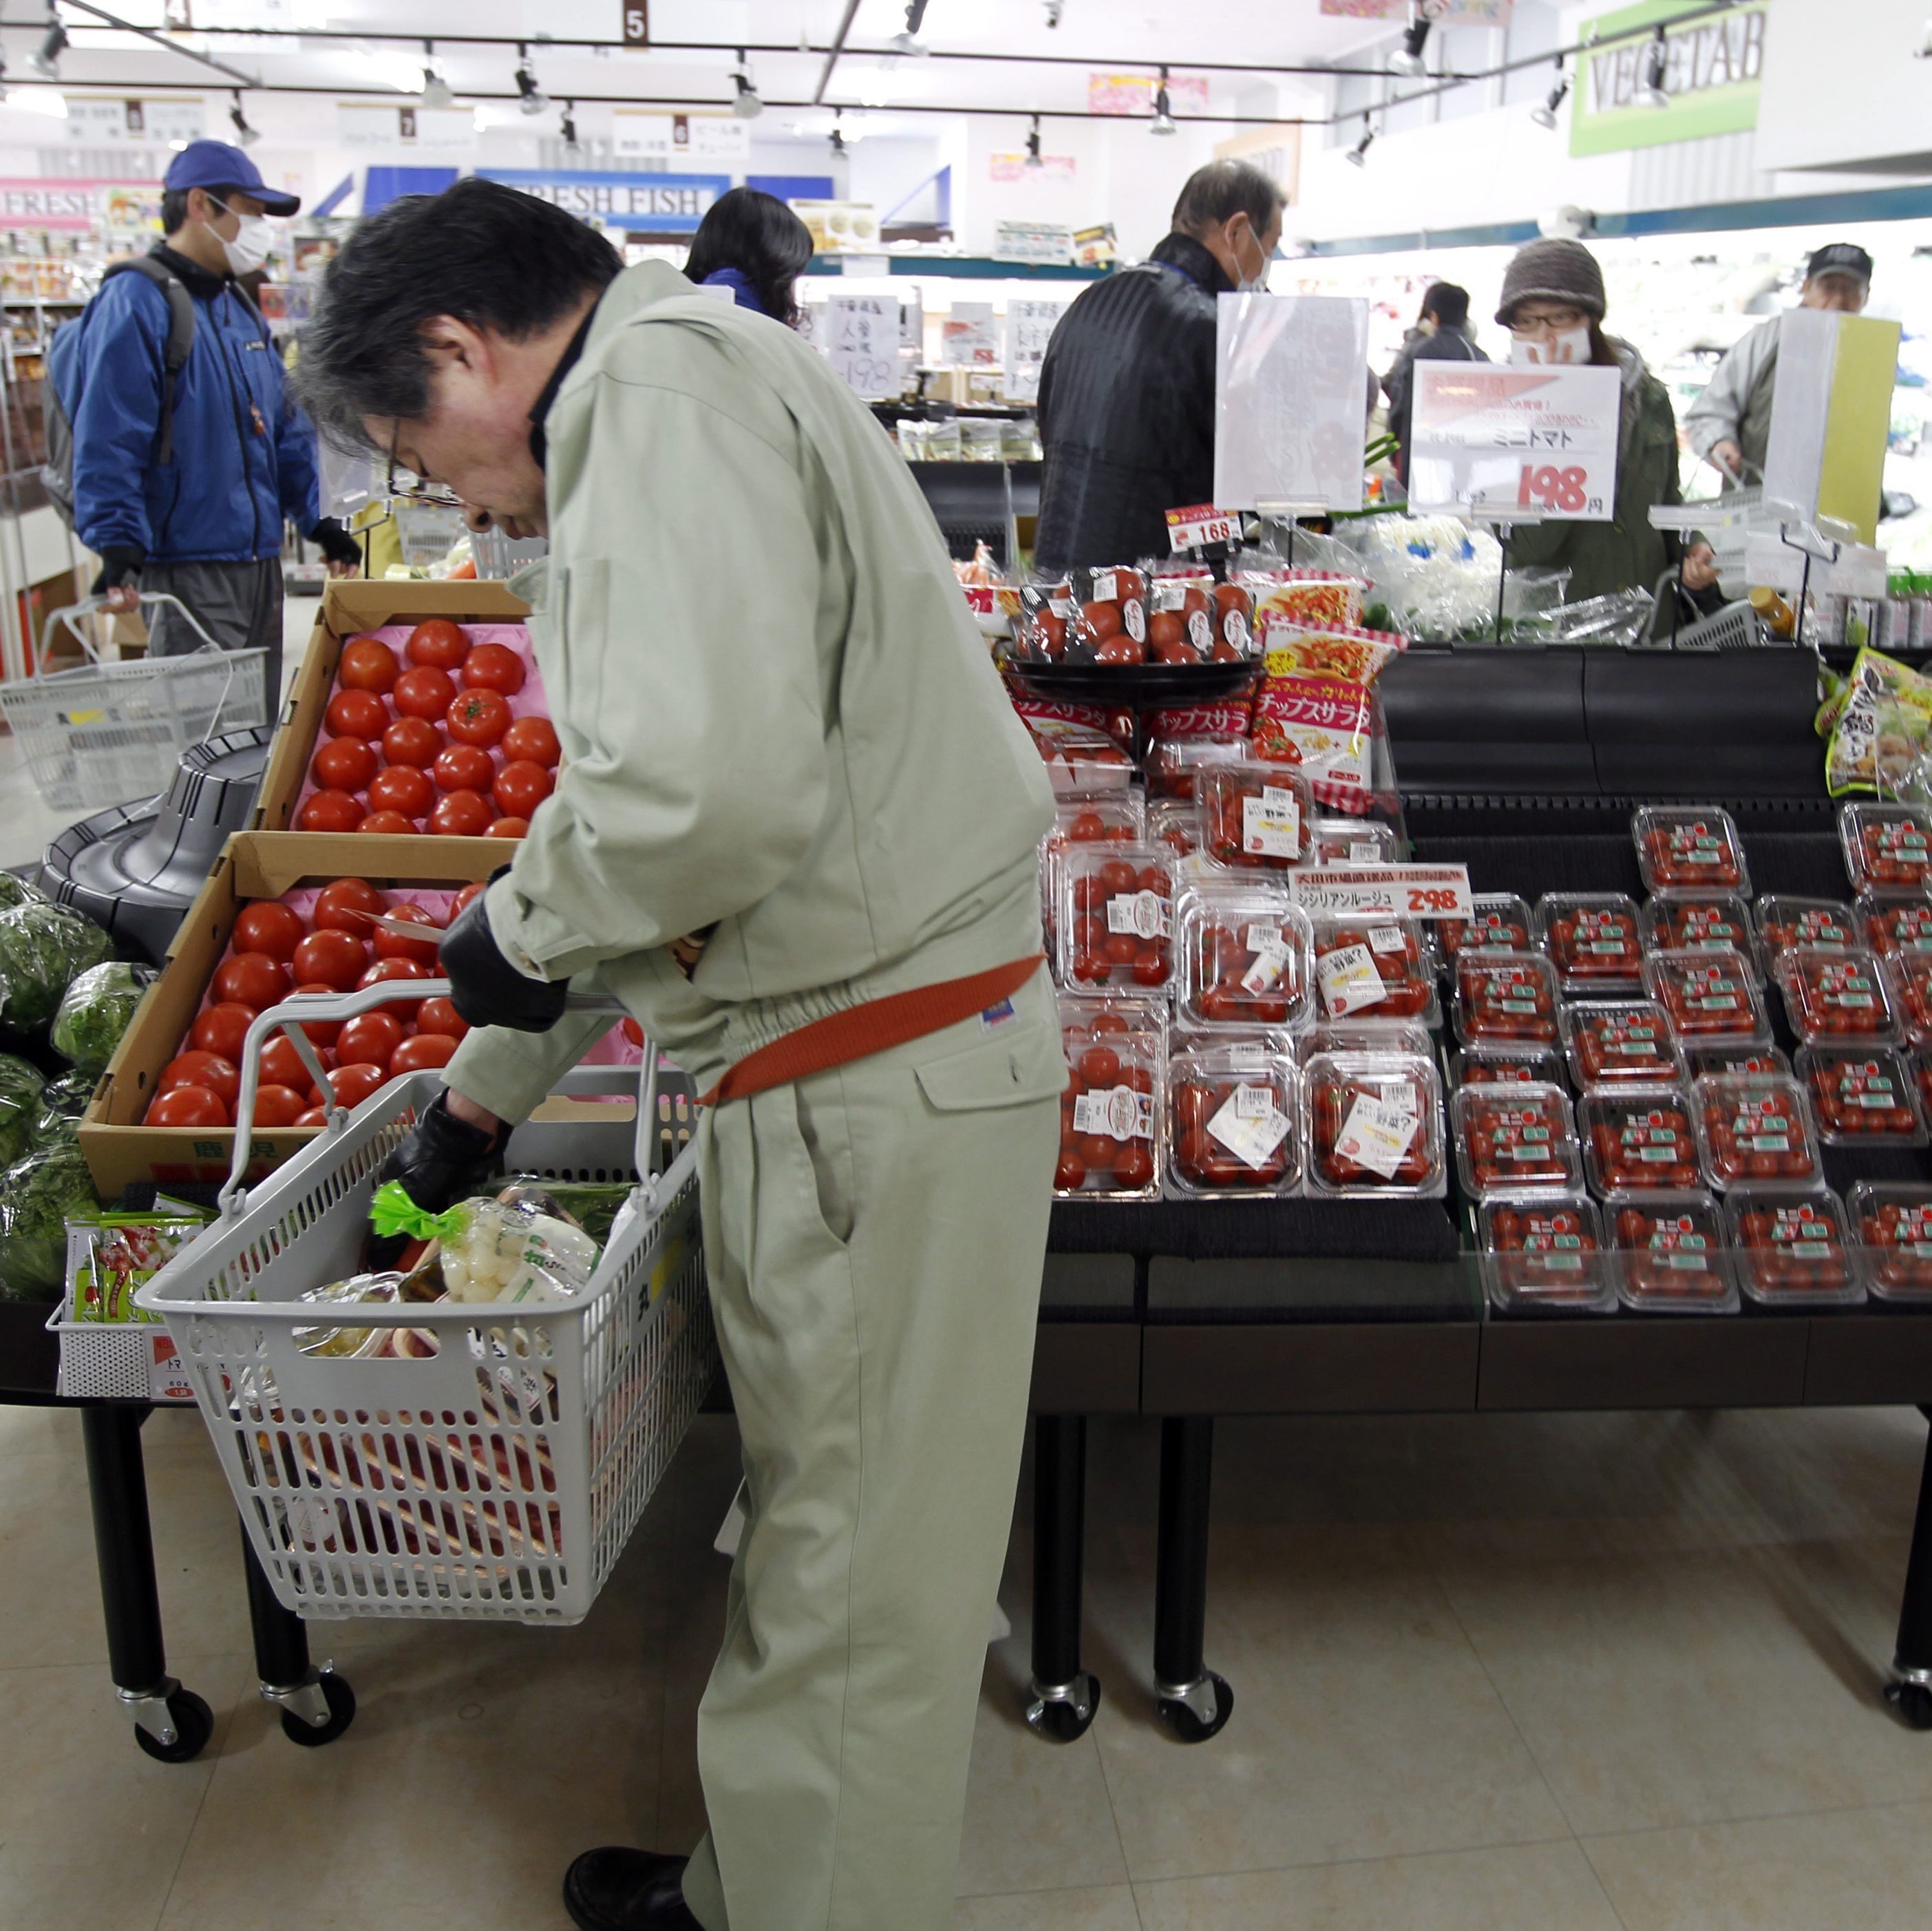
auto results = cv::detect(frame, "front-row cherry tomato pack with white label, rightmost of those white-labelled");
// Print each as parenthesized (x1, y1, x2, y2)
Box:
(1302, 1053, 1449, 1201)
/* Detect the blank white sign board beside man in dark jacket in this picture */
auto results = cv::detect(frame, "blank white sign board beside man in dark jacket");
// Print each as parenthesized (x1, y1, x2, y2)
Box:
(1213, 294, 1370, 510)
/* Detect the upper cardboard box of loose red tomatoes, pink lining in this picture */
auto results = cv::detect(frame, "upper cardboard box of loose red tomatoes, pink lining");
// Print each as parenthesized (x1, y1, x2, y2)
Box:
(253, 582, 560, 839)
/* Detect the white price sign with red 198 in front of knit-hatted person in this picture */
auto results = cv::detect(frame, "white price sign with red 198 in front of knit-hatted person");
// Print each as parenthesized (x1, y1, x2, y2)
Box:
(1408, 361, 1623, 524)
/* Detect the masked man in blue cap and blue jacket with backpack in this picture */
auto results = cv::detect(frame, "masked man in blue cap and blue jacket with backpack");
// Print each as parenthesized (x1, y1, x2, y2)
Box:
(54, 141, 361, 719)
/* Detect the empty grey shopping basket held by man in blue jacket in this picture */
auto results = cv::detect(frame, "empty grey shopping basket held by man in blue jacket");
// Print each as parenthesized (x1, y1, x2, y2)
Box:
(0, 589, 268, 812)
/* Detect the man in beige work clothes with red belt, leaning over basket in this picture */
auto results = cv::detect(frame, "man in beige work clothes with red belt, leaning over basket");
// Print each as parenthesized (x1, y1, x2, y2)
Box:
(301, 180, 1065, 1931)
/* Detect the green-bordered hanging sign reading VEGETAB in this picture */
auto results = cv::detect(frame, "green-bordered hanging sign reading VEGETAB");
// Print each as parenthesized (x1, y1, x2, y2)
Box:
(1571, 0, 1770, 155)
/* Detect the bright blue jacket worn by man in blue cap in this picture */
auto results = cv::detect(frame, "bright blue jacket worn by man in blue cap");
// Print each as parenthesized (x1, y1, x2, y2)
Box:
(62, 249, 321, 562)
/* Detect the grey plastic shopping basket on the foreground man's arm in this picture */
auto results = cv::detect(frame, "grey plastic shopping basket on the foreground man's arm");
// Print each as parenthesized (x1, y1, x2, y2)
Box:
(137, 980, 716, 1624)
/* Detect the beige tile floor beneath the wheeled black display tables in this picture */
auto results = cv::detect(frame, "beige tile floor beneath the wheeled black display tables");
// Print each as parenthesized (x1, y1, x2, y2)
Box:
(0, 1409, 1932, 1931)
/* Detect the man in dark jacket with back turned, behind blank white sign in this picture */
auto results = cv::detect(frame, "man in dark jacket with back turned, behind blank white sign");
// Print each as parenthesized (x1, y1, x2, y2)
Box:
(1034, 160, 1283, 572)
